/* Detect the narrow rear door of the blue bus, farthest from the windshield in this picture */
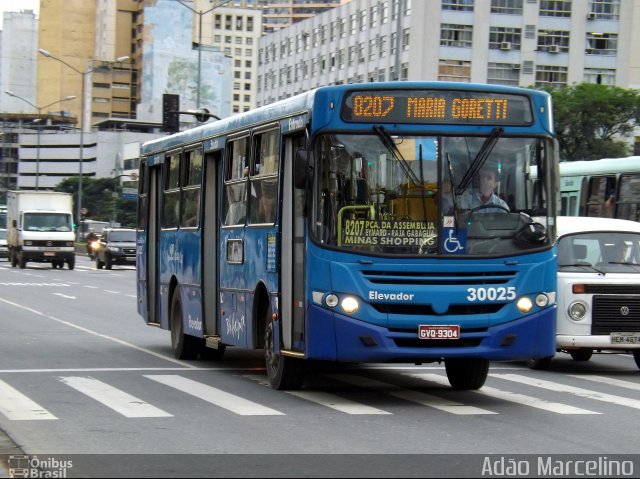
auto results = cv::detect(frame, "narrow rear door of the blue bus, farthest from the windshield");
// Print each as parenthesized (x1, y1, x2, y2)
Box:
(146, 161, 162, 324)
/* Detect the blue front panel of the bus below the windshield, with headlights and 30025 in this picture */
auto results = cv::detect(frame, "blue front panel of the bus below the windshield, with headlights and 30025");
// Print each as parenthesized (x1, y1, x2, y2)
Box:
(306, 246, 557, 361)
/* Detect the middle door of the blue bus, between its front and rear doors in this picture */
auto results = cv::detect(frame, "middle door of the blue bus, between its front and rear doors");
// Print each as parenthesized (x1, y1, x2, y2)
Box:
(205, 150, 222, 339)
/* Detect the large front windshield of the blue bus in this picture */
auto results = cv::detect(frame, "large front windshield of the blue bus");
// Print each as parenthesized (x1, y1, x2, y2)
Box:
(313, 132, 553, 255)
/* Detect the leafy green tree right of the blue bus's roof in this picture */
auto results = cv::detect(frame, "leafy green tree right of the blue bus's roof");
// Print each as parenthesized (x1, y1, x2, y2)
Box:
(543, 83, 640, 161)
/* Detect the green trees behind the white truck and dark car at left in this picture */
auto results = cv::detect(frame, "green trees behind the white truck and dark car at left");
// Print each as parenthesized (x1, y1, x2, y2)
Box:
(54, 176, 137, 227)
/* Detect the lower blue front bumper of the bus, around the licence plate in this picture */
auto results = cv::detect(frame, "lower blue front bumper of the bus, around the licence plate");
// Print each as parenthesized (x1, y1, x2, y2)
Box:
(306, 305, 556, 363)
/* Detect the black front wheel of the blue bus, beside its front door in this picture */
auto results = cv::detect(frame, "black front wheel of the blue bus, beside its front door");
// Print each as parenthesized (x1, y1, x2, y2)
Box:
(264, 319, 305, 390)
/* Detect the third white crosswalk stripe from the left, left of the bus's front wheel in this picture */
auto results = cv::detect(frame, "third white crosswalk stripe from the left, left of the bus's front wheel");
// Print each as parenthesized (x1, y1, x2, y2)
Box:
(145, 374, 284, 416)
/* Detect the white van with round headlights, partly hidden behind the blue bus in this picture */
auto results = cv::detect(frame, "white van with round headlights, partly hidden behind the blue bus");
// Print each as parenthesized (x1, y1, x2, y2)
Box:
(527, 216, 640, 369)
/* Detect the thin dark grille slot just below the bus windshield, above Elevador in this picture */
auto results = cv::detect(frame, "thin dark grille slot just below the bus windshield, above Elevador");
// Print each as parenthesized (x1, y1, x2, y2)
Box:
(362, 270, 516, 286)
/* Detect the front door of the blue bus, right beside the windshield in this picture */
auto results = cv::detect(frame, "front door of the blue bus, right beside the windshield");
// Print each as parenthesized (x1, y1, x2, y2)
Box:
(279, 133, 306, 353)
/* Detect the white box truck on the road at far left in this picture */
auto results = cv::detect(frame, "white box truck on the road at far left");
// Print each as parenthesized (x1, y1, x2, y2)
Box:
(7, 191, 76, 269)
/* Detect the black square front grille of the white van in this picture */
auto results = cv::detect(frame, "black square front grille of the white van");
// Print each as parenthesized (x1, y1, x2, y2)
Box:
(591, 296, 640, 334)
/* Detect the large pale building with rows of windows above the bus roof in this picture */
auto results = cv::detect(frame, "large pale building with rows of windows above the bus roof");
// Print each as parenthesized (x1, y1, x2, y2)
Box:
(257, 0, 640, 105)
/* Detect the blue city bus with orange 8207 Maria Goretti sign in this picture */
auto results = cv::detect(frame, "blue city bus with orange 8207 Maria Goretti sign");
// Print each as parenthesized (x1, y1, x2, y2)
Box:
(137, 82, 558, 389)
